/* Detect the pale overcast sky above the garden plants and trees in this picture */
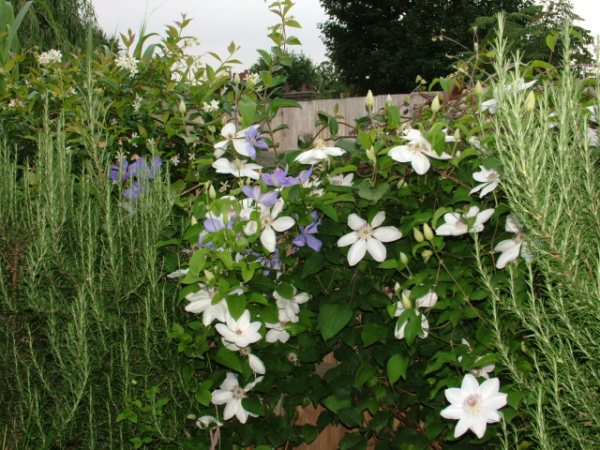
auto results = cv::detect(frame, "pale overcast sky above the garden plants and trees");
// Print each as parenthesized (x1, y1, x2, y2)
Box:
(92, 0, 600, 68)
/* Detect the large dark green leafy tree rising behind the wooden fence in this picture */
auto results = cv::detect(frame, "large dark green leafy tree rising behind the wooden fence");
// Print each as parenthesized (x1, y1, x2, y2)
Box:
(321, 0, 531, 94)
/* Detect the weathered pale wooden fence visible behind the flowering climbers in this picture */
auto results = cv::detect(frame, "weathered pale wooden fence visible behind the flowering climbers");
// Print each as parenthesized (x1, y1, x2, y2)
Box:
(273, 93, 425, 151)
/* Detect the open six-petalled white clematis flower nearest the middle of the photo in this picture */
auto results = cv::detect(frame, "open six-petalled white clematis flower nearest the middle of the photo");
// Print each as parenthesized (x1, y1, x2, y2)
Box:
(337, 211, 402, 266)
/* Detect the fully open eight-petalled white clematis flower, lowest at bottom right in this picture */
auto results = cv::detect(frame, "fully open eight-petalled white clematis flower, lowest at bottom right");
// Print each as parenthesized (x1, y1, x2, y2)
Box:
(441, 373, 507, 439)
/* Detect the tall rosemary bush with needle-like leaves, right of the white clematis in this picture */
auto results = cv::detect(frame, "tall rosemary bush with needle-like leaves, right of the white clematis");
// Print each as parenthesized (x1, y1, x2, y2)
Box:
(478, 21, 600, 449)
